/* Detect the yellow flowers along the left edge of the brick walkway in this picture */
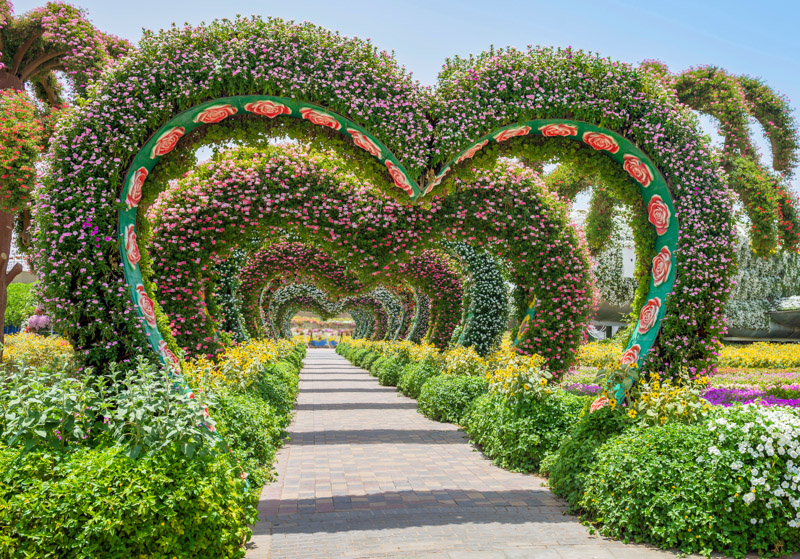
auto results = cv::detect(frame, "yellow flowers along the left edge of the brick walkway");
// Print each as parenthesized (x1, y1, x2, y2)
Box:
(183, 340, 298, 390)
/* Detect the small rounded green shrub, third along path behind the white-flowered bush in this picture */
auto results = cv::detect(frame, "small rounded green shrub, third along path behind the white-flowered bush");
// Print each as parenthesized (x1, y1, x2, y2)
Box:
(417, 375, 487, 423)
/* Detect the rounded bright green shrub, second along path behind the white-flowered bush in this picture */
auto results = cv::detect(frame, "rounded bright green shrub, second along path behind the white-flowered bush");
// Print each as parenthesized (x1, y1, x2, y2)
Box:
(462, 390, 584, 472)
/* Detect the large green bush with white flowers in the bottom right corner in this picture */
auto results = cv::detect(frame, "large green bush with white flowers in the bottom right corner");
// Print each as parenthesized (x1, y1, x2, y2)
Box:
(579, 406, 800, 557)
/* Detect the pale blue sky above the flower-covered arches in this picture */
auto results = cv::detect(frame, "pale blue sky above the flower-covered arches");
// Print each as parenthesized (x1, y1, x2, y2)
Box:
(14, 0, 800, 193)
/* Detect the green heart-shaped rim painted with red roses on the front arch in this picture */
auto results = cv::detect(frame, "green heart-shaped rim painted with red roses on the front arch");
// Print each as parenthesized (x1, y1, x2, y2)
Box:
(118, 95, 679, 378)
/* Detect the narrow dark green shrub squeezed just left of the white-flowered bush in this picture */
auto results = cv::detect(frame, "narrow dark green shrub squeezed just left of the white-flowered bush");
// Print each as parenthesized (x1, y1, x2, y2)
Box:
(541, 402, 628, 505)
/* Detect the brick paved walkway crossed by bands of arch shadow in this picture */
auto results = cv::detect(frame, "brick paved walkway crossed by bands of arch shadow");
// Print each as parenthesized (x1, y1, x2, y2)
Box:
(247, 349, 700, 559)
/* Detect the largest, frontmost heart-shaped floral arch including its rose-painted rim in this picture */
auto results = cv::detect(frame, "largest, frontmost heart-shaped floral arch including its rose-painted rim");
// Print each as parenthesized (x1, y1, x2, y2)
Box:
(35, 18, 732, 382)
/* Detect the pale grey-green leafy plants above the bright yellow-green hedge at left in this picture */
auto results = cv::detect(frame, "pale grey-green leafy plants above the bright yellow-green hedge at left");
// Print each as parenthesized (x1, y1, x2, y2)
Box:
(0, 360, 219, 458)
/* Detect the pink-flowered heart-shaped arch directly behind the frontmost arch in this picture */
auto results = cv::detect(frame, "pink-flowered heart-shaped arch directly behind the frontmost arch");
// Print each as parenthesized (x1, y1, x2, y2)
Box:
(145, 146, 593, 372)
